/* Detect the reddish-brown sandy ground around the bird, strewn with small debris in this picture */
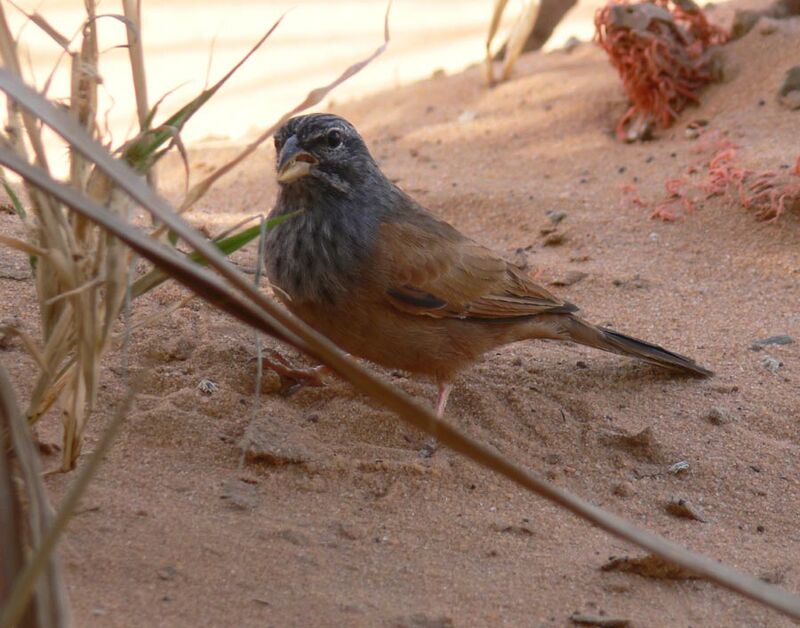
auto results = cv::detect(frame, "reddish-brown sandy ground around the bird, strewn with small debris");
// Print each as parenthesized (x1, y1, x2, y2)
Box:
(0, 2, 800, 627)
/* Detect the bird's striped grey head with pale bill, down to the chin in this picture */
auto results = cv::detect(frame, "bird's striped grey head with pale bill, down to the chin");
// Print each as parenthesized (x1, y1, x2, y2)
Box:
(275, 113, 379, 193)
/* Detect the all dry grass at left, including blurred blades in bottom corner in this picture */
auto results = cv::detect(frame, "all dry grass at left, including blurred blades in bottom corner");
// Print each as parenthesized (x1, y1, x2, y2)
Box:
(0, 0, 389, 628)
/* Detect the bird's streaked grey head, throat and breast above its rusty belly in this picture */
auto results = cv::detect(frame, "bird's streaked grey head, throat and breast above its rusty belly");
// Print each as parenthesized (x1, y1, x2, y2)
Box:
(266, 114, 403, 303)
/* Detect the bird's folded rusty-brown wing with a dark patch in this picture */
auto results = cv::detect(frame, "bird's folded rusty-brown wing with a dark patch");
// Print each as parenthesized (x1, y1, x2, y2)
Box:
(375, 214, 577, 320)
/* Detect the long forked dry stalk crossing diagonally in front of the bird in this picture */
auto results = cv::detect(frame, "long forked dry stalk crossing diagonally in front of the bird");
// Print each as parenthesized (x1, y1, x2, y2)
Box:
(0, 71, 800, 619)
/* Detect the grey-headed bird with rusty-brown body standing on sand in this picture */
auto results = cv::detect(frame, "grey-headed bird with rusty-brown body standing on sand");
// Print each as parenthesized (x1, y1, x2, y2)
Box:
(264, 113, 713, 418)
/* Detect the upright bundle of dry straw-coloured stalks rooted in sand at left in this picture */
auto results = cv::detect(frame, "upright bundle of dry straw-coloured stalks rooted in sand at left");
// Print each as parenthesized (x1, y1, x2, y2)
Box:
(0, 0, 125, 470)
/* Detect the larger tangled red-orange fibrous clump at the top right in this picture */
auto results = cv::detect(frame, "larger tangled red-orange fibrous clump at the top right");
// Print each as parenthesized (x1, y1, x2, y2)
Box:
(595, 0, 727, 141)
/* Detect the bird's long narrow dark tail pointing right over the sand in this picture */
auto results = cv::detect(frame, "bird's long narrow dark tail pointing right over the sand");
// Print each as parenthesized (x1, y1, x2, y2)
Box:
(559, 315, 714, 377)
